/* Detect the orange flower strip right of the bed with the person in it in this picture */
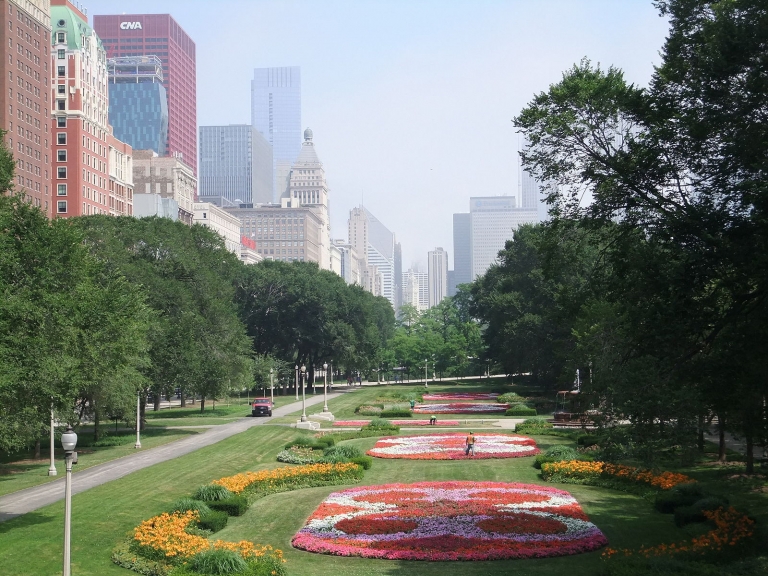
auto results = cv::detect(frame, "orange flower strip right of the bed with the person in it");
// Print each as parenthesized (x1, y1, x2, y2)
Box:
(541, 460, 694, 490)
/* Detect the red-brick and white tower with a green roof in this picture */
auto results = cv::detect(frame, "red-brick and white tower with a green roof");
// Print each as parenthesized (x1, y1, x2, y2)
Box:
(49, 0, 130, 217)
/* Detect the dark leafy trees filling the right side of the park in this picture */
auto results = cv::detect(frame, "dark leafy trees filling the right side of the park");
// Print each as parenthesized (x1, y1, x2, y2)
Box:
(471, 0, 768, 470)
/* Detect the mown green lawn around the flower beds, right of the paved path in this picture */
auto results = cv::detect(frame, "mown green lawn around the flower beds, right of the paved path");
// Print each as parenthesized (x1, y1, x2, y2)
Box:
(0, 386, 768, 576)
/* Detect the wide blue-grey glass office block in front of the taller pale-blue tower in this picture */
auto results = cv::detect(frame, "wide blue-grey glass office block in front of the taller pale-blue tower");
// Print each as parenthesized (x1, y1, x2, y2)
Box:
(198, 124, 272, 206)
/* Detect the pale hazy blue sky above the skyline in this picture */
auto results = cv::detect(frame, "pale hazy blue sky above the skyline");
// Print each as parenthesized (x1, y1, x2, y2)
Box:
(84, 0, 667, 269)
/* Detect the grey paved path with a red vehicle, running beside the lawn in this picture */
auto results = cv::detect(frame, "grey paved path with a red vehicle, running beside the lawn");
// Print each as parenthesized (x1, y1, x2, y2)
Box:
(0, 391, 344, 522)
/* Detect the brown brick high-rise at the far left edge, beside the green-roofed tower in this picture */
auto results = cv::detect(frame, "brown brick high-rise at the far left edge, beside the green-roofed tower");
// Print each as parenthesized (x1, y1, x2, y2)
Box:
(0, 0, 53, 217)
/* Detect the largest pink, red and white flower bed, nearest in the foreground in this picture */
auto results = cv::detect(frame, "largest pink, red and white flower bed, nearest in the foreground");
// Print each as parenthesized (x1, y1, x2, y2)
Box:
(292, 482, 608, 560)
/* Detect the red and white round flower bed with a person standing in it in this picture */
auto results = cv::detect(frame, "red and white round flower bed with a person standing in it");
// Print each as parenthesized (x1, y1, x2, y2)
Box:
(367, 432, 539, 460)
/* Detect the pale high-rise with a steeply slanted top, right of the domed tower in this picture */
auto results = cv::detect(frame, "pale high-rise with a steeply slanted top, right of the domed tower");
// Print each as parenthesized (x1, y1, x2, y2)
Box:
(348, 206, 395, 308)
